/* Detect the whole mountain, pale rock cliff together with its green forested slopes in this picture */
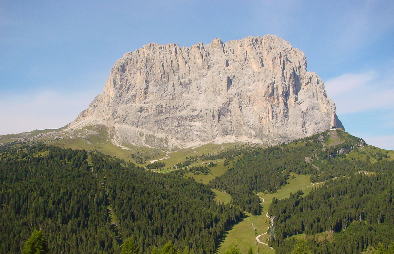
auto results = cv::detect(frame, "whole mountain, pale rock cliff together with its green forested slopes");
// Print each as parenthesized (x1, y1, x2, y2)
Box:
(0, 35, 394, 254)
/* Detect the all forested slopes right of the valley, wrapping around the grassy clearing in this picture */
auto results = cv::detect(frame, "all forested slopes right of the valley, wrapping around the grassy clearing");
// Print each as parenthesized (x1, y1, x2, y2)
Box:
(206, 130, 394, 253)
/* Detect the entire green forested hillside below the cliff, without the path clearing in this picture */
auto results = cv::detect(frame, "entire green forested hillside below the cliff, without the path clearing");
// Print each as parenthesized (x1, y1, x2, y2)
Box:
(0, 130, 394, 254)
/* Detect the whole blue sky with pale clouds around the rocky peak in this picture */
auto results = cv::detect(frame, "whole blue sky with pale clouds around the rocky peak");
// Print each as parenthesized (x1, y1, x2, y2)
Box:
(0, 0, 394, 149)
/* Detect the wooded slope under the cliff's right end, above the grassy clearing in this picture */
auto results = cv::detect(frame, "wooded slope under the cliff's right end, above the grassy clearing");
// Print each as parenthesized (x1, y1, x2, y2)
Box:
(210, 131, 368, 214)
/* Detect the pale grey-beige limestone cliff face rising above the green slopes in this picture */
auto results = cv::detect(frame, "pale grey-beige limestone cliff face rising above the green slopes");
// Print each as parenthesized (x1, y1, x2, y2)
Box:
(68, 35, 341, 148)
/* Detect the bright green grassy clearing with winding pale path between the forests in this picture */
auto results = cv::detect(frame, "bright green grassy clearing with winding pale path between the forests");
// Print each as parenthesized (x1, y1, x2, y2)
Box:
(218, 174, 313, 254)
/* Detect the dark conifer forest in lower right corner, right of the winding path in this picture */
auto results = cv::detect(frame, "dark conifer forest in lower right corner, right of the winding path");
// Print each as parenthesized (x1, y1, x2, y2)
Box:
(269, 171, 394, 254)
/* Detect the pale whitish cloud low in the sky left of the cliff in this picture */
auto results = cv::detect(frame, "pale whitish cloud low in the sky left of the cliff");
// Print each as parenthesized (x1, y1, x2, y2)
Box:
(0, 91, 95, 135)
